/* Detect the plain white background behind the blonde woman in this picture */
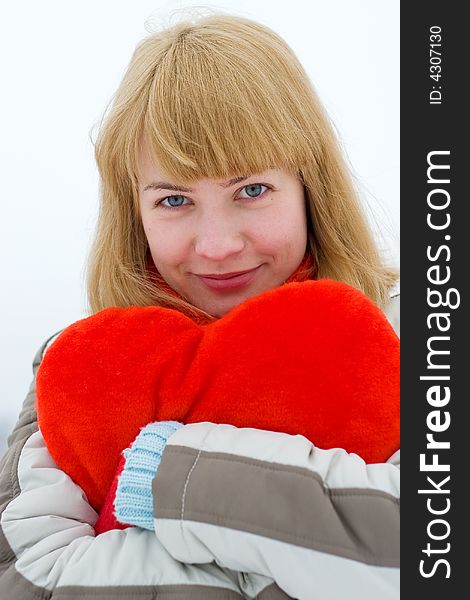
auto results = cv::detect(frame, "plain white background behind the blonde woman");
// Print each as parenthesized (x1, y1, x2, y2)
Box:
(0, 0, 399, 453)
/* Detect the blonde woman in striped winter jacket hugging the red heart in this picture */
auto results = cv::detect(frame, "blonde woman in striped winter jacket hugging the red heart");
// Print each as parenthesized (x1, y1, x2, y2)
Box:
(0, 16, 399, 599)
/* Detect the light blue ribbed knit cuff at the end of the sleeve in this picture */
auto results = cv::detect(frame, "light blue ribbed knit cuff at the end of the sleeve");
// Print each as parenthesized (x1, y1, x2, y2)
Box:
(114, 421, 183, 530)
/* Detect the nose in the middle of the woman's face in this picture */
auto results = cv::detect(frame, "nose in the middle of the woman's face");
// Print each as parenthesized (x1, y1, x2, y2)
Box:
(194, 214, 245, 261)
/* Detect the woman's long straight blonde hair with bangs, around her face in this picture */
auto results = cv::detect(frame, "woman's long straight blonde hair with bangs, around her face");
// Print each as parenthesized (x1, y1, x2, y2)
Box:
(88, 15, 397, 314)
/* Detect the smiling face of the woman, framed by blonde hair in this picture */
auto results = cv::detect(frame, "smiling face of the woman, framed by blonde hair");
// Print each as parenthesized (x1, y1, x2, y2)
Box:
(139, 149, 307, 317)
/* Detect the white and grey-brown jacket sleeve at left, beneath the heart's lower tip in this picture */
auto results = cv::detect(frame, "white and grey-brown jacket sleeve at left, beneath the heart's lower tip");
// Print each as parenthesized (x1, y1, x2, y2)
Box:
(0, 338, 264, 600)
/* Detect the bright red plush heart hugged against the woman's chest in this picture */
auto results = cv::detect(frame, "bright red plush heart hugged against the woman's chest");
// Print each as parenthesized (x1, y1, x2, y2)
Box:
(37, 279, 399, 510)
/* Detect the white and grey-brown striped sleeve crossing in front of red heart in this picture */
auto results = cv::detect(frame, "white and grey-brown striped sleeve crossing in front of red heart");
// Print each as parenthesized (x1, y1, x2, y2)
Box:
(153, 423, 399, 600)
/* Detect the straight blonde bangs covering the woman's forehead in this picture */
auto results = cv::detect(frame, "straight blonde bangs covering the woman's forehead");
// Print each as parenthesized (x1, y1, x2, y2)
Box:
(138, 25, 305, 182)
